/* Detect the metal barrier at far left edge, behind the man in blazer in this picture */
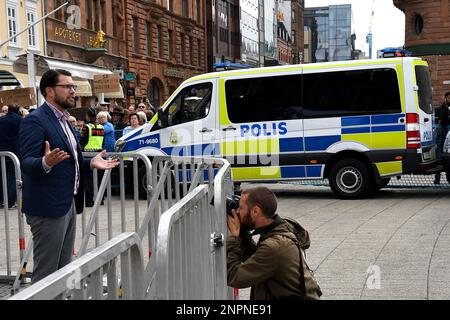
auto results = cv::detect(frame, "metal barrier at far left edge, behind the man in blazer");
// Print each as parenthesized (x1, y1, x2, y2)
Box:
(0, 151, 26, 297)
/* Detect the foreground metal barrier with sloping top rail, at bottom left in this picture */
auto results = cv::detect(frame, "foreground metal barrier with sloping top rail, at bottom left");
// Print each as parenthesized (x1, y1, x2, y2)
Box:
(10, 232, 144, 300)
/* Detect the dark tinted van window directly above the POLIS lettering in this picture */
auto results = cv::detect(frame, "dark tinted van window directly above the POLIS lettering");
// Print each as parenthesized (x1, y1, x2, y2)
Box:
(225, 75, 302, 123)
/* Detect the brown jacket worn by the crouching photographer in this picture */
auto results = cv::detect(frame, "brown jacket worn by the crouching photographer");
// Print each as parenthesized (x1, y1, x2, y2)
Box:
(227, 217, 301, 300)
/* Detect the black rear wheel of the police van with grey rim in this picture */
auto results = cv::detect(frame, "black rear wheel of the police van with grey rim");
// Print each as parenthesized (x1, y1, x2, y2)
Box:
(329, 159, 373, 199)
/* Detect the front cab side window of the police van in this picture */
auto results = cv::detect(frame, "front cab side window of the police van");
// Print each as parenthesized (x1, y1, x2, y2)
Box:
(164, 82, 212, 127)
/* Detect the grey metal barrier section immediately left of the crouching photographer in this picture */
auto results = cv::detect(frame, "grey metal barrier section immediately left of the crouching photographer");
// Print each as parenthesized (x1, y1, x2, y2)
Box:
(156, 185, 216, 300)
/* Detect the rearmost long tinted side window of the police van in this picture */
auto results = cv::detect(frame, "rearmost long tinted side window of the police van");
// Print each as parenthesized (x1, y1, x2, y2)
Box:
(303, 68, 401, 118)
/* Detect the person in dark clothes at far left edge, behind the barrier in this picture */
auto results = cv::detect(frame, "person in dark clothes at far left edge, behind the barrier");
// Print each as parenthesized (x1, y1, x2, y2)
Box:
(0, 104, 22, 209)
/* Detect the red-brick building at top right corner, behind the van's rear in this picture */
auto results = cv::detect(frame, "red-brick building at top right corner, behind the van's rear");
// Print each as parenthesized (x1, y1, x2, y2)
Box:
(393, 0, 450, 106)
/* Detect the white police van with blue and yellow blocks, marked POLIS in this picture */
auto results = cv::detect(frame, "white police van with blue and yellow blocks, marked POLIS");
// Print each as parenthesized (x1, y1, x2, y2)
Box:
(116, 57, 437, 198)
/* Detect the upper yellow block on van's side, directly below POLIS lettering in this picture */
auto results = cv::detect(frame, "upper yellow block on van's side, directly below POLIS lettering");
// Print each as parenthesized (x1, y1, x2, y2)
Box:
(221, 138, 280, 156)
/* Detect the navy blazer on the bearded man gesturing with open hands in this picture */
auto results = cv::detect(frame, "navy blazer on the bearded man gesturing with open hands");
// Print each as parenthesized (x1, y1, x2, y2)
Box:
(20, 103, 89, 217)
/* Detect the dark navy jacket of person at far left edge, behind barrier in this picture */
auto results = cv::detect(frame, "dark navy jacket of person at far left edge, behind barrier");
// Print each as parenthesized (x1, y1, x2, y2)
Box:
(0, 113, 22, 156)
